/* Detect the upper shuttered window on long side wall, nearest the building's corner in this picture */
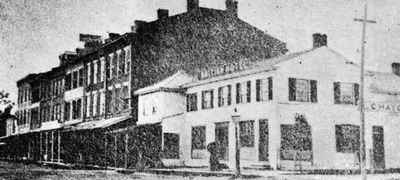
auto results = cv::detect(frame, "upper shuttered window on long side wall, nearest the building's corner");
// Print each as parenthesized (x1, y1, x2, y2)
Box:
(256, 77, 273, 102)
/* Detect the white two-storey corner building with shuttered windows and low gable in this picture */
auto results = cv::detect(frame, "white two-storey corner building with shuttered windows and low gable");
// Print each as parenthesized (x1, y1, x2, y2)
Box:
(135, 36, 400, 169)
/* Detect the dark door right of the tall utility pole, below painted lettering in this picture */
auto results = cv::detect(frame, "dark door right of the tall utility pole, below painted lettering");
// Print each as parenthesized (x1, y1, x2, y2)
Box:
(372, 126, 385, 169)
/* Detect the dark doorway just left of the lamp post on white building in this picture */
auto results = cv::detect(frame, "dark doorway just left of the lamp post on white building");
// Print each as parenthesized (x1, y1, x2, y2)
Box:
(215, 122, 229, 160)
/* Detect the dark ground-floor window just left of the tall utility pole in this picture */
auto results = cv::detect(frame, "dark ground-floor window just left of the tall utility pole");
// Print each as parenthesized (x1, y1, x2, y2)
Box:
(335, 124, 360, 153)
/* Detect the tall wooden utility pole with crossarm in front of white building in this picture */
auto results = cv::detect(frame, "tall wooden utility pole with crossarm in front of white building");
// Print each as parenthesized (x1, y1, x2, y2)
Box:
(354, 0, 376, 180)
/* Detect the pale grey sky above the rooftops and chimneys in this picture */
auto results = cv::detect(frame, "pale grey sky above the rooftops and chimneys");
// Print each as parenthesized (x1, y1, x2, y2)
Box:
(0, 0, 400, 107)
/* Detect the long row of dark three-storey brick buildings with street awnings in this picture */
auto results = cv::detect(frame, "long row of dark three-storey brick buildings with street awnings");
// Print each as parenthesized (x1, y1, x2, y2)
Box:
(0, 0, 288, 167)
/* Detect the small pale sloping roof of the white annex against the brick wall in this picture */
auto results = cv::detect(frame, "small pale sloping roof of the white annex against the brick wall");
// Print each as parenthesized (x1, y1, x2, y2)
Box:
(135, 71, 194, 95)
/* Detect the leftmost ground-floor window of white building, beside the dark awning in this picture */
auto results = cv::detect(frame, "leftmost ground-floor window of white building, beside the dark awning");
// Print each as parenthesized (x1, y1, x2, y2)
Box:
(164, 133, 179, 159)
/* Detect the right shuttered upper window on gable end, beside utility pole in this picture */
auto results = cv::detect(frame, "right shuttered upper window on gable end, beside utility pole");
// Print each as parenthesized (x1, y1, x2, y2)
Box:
(333, 82, 359, 105)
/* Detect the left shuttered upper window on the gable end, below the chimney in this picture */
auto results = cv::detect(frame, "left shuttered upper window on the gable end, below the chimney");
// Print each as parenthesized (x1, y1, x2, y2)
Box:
(289, 78, 318, 102)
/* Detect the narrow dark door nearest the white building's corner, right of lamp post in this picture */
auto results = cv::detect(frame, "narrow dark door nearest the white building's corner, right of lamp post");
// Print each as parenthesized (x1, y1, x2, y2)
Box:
(258, 119, 268, 161)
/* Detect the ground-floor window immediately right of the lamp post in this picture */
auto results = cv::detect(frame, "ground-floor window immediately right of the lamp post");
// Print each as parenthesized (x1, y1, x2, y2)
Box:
(239, 121, 254, 147)
